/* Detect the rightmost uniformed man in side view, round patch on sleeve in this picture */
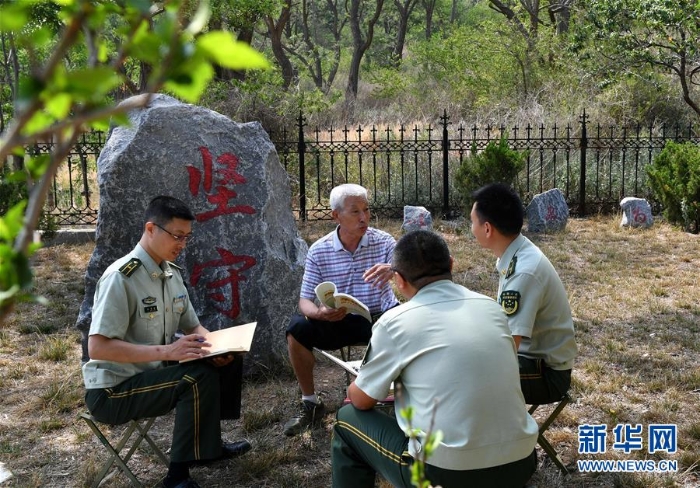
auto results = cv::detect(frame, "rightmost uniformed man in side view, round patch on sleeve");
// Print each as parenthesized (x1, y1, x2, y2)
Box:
(471, 183, 578, 404)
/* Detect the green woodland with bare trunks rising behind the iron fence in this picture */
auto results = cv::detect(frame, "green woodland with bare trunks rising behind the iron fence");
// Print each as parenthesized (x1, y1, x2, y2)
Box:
(0, 0, 700, 135)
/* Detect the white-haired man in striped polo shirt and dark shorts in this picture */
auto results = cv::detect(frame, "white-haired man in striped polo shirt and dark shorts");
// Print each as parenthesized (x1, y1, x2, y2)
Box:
(284, 183, 398, 436)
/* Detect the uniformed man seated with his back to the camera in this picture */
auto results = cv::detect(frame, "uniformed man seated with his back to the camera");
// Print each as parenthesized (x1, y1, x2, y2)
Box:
(331, 230, 538, 488)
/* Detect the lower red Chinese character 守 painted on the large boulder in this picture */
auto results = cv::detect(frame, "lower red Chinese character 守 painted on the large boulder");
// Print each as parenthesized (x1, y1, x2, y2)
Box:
(191, 247, 257, 319)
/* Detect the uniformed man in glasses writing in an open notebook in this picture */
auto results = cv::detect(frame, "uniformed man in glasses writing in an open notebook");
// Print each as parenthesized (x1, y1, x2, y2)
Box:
(83, 196, 250, 488)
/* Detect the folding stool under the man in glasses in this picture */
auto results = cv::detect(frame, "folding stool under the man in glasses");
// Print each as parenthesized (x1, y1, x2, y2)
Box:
(80, 413, 170, 488)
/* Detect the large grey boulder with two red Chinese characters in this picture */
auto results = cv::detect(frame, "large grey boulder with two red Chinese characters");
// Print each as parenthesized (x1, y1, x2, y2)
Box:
(76, 95, 308, 365)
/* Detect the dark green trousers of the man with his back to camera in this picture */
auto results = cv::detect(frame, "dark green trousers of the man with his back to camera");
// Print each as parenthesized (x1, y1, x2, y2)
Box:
(331, 405, 537, 488)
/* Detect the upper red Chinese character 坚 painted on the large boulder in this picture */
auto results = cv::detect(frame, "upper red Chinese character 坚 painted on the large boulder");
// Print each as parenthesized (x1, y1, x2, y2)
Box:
(187, 146, 255, 222)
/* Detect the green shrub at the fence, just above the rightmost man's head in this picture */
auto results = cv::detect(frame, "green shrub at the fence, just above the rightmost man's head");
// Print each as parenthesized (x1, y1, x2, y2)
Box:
(455, 137, 527, 214)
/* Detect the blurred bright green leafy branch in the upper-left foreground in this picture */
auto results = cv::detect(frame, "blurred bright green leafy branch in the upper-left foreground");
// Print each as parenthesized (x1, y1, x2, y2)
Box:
(0, 0, 267, 321)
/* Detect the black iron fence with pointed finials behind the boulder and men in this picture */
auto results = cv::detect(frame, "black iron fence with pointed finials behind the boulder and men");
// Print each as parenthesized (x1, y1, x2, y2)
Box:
(32, 112, 700, 225)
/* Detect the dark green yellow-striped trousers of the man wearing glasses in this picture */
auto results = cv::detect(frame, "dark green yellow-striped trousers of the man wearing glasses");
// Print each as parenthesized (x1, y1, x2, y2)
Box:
(85, 358, 242, 462)
